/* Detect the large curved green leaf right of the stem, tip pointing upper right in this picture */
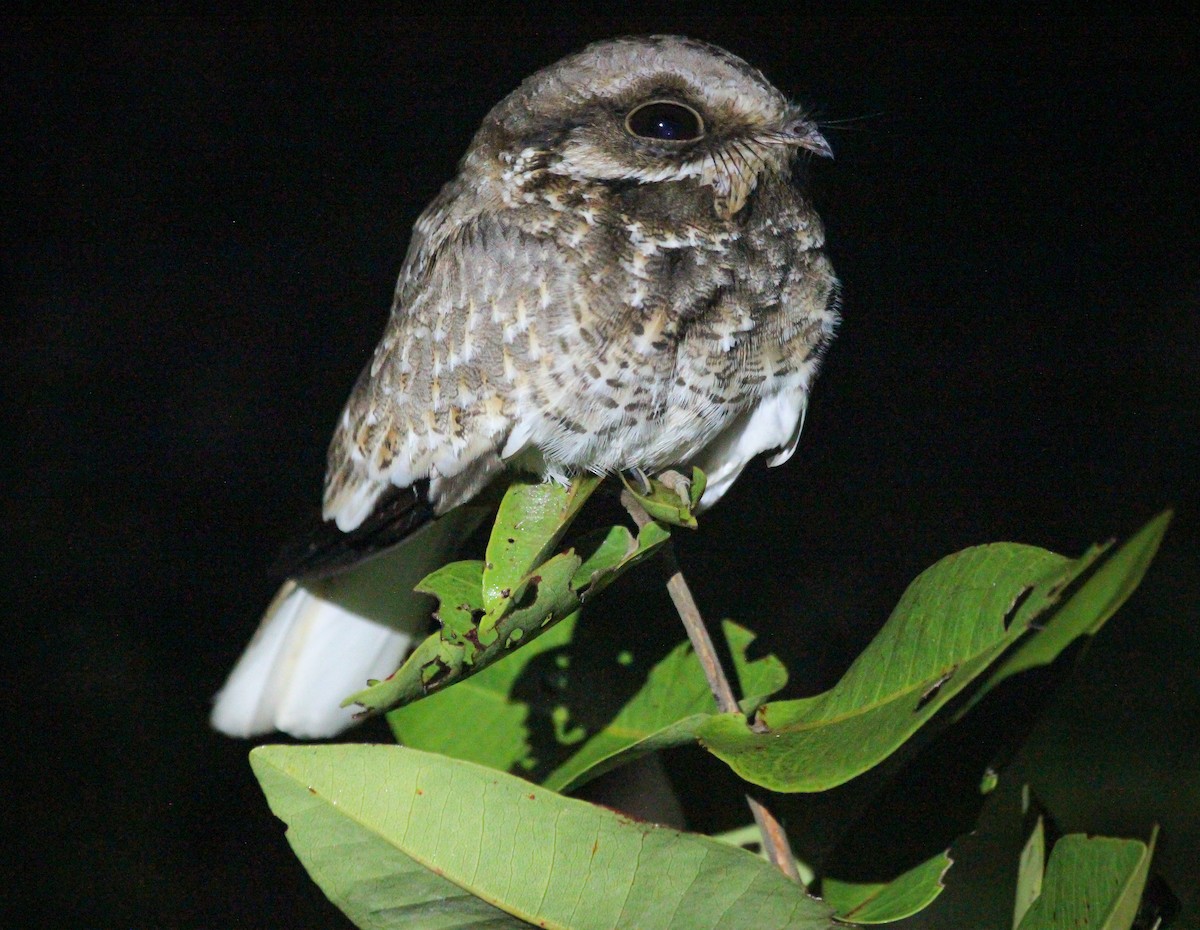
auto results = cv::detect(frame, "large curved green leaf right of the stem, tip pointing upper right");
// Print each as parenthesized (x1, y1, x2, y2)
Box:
(698, 544, 1098, 791)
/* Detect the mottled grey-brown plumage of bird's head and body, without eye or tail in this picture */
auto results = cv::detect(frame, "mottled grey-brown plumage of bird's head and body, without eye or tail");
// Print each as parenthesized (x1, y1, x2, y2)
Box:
(324, 37, 836, 530)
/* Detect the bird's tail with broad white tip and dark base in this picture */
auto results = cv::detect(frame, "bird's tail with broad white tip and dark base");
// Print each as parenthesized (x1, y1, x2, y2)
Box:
(210, 508, 479, 739)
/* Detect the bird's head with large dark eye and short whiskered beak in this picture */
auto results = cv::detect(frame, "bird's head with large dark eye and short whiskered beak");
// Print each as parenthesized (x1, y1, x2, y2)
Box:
(464, 36, 832, 218)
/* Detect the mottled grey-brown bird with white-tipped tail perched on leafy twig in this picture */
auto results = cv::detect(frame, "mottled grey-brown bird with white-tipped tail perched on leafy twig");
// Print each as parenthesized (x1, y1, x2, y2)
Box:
(212, 36, 838, 737)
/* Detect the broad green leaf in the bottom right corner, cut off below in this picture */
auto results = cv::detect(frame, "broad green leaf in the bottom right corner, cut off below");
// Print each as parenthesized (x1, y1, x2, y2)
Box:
(1020, 828, 1158, 930)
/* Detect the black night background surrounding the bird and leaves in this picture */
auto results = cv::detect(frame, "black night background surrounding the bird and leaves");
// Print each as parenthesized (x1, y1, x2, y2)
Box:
(0, 12, 1200, 928)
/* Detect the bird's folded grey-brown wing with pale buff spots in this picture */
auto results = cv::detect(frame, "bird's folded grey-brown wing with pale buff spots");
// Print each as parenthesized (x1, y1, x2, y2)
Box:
(323, 218, 565, 533)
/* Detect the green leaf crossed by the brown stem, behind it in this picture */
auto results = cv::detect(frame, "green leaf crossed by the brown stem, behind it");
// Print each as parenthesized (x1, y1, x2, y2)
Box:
(544, 620, 787, 791)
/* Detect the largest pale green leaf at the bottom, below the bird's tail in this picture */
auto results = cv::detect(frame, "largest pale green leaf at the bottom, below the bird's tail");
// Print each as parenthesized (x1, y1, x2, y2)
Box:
(251, 744, 835, 930)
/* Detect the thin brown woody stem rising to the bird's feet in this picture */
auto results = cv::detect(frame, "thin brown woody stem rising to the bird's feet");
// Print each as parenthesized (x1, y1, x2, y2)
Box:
(620, 491, 800, 883)
